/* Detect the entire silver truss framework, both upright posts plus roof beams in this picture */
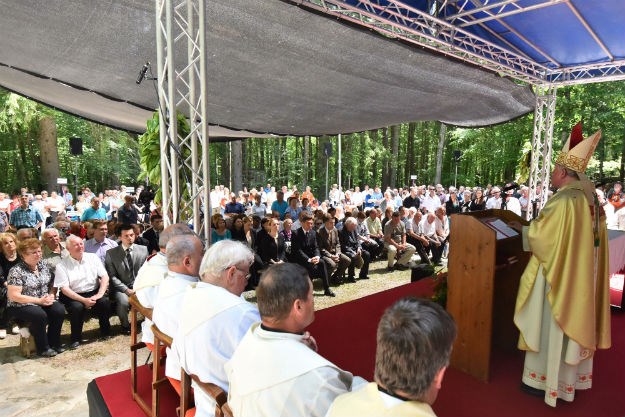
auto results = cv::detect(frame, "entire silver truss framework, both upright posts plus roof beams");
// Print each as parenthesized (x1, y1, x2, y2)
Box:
(155, 0, 625, 228)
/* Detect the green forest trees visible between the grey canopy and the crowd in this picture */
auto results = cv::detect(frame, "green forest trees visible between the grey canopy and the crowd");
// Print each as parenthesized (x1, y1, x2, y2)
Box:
(0, 81, 625, 200)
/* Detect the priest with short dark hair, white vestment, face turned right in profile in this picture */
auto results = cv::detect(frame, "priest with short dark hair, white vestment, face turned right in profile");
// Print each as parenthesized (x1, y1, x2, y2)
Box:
(225, 263, 360, 417)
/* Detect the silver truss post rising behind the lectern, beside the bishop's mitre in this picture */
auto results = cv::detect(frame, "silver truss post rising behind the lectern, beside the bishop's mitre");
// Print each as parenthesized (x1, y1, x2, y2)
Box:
(527, 85, 556, 220)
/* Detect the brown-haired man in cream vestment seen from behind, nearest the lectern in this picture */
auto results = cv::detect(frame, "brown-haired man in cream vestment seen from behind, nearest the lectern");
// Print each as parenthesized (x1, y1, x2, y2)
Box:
(326, 297, 456, 417)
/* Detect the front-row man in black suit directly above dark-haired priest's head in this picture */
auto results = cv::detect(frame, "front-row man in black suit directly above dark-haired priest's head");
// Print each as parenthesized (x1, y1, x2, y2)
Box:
(291, 212, 335, 297)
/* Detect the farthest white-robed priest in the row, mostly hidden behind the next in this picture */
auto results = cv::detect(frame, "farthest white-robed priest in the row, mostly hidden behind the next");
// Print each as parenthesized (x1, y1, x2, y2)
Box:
(134, 223, 193, 350)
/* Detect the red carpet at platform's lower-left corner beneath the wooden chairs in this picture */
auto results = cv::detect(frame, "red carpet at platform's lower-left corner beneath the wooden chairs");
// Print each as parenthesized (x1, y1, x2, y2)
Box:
(95, 365, 180, 417)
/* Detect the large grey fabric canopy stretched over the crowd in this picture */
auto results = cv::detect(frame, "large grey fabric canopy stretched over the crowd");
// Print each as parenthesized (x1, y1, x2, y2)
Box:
(0, 0, 535, 137)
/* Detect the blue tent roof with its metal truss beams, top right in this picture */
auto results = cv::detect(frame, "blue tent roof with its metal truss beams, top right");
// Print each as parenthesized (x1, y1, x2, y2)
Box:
(310, 0, 625, 84)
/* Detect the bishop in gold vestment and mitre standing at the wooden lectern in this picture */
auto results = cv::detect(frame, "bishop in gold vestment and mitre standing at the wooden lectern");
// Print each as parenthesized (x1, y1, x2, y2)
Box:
(510, 124, 611, 407)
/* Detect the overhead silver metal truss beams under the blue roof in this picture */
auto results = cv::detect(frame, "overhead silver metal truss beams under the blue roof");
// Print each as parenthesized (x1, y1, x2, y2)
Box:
(292, 0, 625, 86)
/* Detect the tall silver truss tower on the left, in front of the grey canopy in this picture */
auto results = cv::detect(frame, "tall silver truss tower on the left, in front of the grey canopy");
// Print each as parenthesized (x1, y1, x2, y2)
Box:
(155, 0, 210, 241)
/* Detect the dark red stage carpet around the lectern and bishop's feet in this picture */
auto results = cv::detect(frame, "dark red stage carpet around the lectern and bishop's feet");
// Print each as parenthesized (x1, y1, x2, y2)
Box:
(309, 280, 625, 417)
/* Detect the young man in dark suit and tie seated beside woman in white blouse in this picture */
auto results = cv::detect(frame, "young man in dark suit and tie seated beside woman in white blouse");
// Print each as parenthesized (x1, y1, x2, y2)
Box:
(104, 224, 148, 334)
